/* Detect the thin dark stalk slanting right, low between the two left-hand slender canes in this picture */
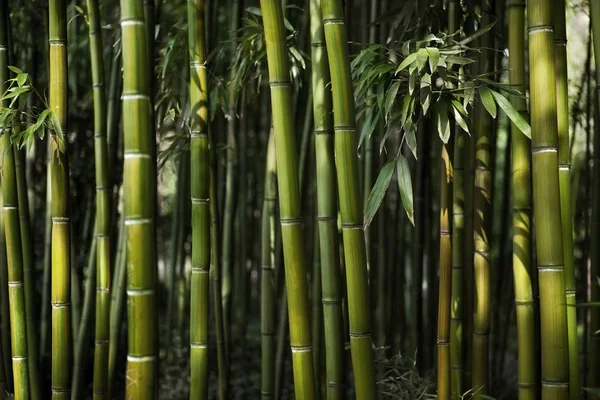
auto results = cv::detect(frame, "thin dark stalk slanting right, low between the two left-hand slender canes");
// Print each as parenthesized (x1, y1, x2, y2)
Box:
(71, 233, 97, 400)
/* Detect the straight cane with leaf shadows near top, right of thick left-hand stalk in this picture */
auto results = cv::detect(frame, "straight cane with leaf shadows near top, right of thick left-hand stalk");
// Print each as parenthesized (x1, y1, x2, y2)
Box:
(188, 0, 210, 399)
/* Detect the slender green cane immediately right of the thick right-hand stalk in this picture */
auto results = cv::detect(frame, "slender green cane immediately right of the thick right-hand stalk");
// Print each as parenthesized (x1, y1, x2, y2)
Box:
(552, 0, 579, 400)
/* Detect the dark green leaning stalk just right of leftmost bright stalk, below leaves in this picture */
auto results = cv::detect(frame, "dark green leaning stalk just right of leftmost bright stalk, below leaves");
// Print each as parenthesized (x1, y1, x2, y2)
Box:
(15, 142, 41, 400)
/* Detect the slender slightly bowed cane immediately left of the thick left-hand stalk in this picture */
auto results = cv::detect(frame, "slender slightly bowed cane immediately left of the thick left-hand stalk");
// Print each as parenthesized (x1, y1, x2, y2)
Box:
(87, 0, 112, 399)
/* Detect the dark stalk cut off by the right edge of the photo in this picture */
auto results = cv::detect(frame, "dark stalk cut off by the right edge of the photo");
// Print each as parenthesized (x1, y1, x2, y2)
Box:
(586, 1, 600, 394)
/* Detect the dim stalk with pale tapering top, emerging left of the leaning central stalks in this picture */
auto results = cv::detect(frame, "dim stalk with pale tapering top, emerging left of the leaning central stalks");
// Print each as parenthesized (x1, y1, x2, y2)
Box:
(260, 129, 277, 400)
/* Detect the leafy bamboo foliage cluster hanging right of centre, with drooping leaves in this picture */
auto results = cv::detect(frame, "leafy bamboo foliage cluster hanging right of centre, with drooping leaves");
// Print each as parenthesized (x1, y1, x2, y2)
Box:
(352, 24, 531, 225)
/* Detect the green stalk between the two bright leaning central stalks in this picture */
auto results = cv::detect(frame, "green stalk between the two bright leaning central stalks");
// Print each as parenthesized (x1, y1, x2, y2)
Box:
(310, 0, 345, 400)
